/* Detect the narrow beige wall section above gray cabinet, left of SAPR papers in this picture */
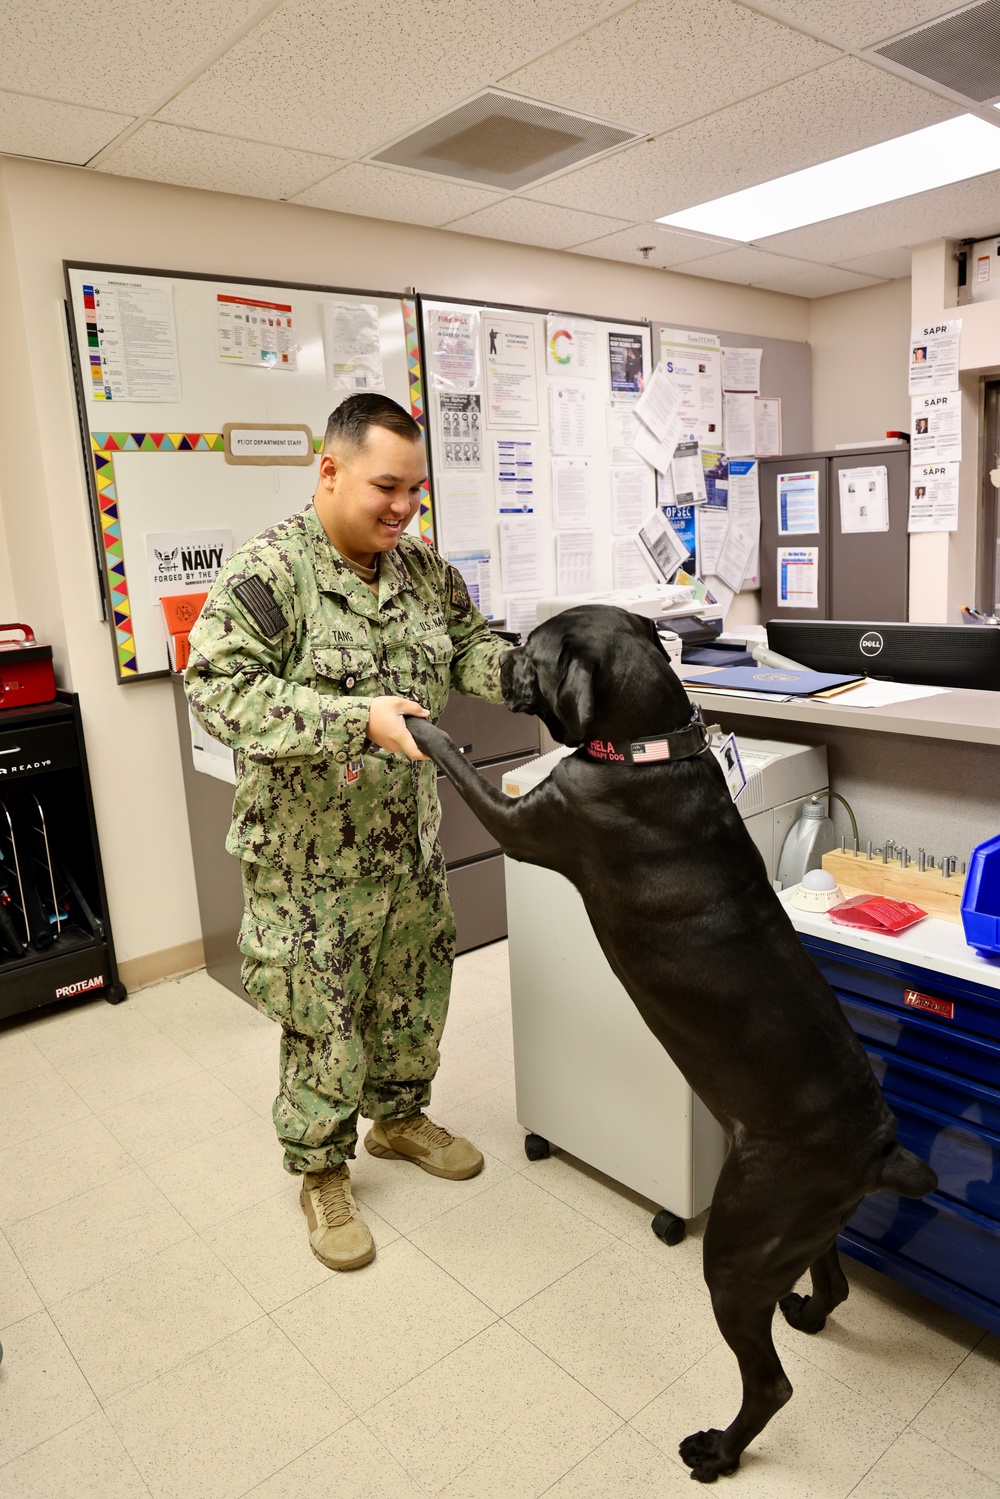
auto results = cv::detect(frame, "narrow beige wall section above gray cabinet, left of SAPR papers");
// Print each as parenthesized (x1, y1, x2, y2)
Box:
(808, 279, 910, 450)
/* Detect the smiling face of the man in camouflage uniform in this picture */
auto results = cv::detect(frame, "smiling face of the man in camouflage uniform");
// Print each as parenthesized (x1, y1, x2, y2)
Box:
(313, 426, 427, 567)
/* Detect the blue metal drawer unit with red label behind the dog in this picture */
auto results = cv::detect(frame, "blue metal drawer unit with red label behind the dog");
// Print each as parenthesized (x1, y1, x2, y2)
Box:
(799, 932, 1000, 1333)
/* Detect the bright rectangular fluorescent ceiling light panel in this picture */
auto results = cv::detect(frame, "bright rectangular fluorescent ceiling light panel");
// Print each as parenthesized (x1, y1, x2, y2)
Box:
(657, 114, 1000, 241)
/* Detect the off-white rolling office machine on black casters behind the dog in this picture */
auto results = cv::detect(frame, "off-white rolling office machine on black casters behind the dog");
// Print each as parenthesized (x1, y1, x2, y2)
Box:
(504, 738, 828, 1244)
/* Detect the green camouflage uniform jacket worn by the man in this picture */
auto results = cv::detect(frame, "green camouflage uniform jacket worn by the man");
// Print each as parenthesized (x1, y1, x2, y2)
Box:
(184, 504, 508, 880)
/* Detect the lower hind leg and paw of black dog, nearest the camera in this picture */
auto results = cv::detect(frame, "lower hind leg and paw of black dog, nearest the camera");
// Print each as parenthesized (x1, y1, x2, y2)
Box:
(681, 1285, 792, 1484)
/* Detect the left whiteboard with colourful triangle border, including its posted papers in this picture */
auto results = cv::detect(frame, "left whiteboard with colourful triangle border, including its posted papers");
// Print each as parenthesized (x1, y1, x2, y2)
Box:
(64, 262, 422, 684)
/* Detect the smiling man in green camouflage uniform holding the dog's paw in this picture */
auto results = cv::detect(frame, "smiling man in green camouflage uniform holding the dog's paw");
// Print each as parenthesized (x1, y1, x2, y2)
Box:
(186, 394, 507, 1270)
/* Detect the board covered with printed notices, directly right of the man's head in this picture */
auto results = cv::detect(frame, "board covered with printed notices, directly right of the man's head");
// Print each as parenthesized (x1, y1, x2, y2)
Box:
(418, 295, 657, 630)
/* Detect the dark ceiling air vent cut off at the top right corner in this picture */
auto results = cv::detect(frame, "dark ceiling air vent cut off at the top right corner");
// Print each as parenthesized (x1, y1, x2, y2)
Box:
(874, 0, 1000, 103)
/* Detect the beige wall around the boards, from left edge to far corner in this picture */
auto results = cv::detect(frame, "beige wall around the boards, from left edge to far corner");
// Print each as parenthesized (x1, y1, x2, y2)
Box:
(0, 159, 808, 959)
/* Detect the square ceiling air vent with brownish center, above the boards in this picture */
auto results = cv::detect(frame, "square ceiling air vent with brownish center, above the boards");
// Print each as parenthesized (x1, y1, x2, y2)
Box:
(369, 88, 643, 190)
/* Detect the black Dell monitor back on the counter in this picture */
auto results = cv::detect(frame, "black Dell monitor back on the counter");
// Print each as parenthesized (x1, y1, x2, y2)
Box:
(768, 619, 1000, 693)
